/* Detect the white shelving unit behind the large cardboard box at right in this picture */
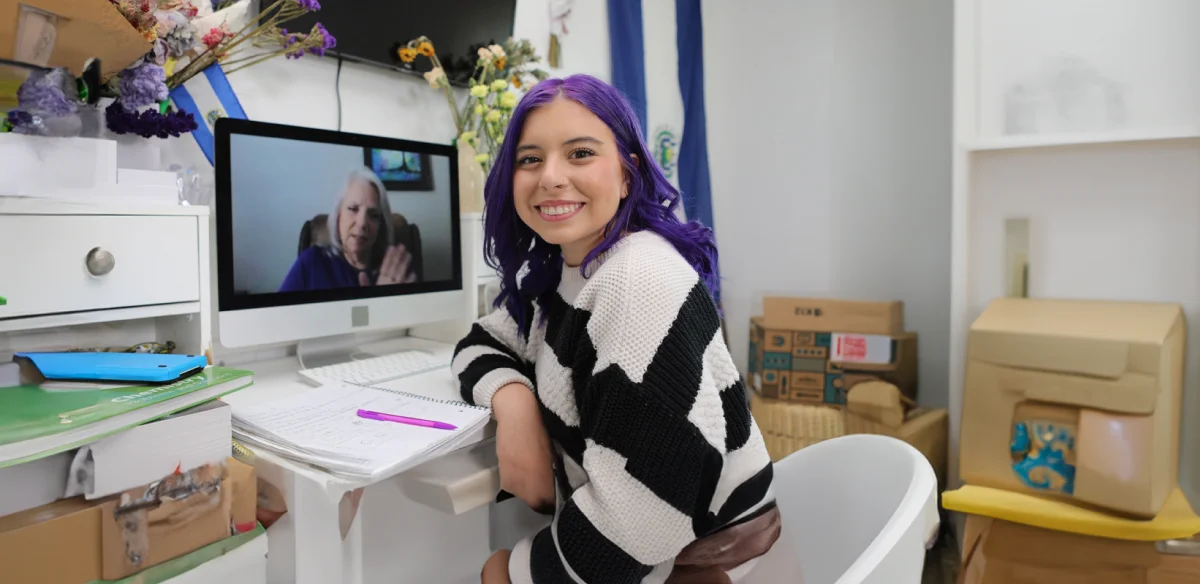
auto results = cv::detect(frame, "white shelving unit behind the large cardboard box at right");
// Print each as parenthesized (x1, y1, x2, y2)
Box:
(949, 0, 1200, 502)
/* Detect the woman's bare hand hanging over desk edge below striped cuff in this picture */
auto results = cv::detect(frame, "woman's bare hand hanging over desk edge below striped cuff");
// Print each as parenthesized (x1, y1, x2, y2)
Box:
(492, 384, 554, 511)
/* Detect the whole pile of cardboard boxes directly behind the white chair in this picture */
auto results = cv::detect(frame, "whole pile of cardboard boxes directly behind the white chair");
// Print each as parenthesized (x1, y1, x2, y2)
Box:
(748, 297, 948, 480)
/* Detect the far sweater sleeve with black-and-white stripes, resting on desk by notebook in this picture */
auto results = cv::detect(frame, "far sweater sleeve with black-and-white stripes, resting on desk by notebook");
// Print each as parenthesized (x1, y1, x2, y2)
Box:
(451, 308, 534, 408)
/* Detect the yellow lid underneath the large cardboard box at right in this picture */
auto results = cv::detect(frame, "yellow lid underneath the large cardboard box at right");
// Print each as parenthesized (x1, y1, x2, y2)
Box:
(942, 484, 1200, 541)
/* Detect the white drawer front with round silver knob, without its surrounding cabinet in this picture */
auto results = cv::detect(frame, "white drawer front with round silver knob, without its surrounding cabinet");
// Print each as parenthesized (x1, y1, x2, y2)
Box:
(0, 215, 200, 318)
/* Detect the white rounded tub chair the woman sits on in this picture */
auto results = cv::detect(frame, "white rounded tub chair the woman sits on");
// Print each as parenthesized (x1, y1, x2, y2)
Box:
(743, 434, 938, 584)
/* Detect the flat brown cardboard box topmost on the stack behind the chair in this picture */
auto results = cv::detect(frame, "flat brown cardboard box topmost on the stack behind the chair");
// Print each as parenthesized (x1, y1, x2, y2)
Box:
(762, 296, 905, 335)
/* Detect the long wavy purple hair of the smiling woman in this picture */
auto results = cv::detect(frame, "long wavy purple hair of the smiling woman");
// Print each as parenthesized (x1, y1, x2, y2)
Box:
(484, 76, 719, 335)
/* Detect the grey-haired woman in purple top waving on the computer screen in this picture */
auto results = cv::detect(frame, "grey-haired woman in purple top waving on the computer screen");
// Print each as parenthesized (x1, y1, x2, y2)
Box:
(280, 167, 416, 291)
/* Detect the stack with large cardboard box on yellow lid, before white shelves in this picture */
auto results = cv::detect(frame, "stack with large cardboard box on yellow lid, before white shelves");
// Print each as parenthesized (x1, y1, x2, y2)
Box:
(943, 299, 1200, 584)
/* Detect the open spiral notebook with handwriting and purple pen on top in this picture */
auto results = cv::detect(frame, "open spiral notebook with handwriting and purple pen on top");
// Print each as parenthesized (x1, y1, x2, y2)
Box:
(233, 381, 491, 480)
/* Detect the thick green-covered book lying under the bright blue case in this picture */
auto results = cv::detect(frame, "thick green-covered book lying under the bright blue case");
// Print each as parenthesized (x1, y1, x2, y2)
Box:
(0, 367, 253, 468)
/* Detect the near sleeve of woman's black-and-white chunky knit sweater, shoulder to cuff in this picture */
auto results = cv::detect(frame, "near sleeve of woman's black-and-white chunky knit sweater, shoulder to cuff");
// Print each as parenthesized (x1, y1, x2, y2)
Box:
(509, 258, 769, 584)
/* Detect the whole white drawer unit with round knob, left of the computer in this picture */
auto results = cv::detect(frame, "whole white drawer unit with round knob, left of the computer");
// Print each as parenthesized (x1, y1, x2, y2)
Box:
(0, 197, 212, 361)
